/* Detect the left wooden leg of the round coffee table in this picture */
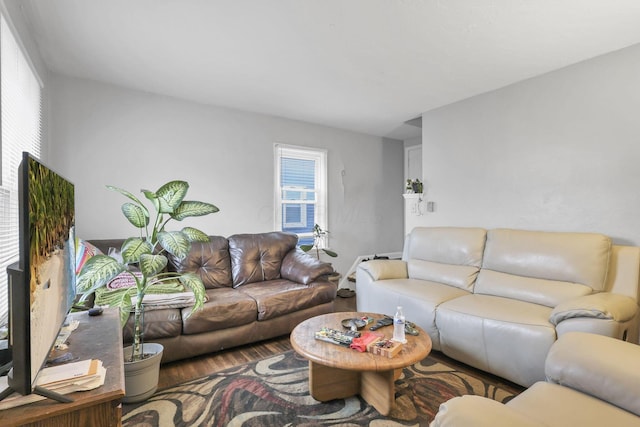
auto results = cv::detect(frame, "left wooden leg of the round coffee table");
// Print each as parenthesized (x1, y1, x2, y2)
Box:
(309, 361, 360, 402)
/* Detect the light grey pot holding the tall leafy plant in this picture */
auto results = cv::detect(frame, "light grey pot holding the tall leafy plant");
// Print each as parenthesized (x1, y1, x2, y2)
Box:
(122, 343, 164, 403)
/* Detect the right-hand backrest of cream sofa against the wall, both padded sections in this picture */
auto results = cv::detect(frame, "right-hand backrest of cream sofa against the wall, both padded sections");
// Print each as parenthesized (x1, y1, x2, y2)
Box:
(474, 229, 611, 307)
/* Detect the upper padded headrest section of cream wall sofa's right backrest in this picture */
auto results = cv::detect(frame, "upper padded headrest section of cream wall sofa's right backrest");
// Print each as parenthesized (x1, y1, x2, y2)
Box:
(476, 229, 611, 293)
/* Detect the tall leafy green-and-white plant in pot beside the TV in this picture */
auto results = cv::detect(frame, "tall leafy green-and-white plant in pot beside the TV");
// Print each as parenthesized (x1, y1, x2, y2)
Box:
(77, 181, 218, 402)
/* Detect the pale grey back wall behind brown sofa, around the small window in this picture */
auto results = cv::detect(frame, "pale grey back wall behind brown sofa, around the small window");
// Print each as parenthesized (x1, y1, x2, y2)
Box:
(51, 74, 403, 272)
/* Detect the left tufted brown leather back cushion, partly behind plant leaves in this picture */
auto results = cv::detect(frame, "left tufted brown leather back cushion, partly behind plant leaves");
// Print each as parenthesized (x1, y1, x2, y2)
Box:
(169, 236, 232, 289)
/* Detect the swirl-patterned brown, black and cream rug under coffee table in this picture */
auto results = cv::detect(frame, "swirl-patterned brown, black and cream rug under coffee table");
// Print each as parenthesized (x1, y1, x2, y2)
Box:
(122, 351, 519, 427)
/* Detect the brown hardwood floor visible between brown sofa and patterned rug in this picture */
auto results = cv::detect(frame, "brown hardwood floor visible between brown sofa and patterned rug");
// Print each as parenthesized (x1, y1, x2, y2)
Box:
(158, 297, 356, 390)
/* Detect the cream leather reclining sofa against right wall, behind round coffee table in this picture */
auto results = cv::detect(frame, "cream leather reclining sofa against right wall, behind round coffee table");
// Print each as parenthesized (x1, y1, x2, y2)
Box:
(356, 227, 640, 387)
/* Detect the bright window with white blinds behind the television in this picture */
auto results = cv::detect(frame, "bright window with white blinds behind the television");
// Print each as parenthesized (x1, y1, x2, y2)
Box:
(0, 13, 42, 324)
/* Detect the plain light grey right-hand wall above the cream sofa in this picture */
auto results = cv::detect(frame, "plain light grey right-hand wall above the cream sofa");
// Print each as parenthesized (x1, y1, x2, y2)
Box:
(419, 41, 640, 245)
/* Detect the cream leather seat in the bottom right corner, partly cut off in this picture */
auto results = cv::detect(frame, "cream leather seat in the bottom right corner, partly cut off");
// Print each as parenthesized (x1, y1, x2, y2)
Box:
(431, 332, 640, 427)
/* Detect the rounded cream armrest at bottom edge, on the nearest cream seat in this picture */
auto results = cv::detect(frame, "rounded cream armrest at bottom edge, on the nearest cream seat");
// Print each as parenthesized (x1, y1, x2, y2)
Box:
(429, 395, 540, 427)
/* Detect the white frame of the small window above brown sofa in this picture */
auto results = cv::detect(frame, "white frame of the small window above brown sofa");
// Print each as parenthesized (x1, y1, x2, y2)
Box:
(273, 143, 329, 247)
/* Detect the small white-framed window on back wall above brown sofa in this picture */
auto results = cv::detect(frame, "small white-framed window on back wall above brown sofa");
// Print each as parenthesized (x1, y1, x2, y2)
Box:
(275, 144, 327, 245)
